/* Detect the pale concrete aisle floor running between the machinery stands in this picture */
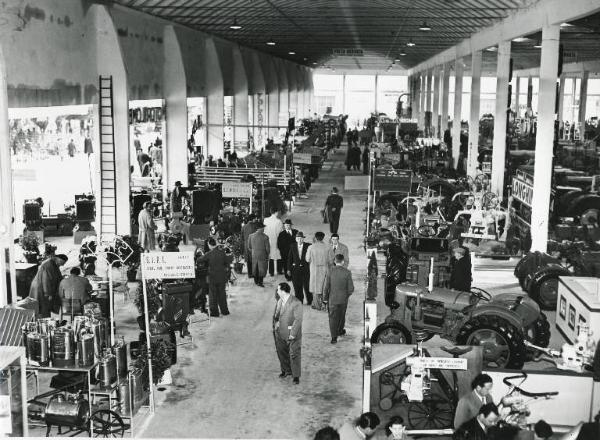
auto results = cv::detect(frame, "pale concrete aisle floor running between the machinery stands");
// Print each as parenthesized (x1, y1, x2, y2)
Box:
(140, 149, 366, 438)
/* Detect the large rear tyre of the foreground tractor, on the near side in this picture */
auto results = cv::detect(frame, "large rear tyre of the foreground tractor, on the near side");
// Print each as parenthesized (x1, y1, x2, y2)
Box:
(456, 315, 527, 370)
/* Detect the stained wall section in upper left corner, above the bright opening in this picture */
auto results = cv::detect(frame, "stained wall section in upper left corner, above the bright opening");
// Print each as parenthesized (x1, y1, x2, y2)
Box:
(0, 0, 97, 107)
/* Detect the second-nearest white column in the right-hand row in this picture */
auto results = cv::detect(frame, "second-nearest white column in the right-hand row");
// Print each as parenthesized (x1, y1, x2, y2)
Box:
(491, 40, 511, 197)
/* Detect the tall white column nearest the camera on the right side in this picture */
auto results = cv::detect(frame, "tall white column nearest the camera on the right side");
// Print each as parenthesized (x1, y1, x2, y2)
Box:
(531, 24, 560, 252)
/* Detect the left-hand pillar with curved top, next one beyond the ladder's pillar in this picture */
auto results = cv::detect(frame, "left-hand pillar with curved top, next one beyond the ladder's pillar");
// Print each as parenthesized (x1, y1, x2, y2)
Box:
(163, 26, 188, 189)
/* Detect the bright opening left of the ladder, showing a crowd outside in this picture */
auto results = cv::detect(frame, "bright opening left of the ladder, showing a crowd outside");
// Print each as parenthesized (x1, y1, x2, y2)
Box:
(8, 105, 99, 230)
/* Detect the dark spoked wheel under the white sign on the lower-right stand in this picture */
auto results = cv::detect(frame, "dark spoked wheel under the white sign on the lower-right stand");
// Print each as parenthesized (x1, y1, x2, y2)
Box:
(408, 394, 454, 429)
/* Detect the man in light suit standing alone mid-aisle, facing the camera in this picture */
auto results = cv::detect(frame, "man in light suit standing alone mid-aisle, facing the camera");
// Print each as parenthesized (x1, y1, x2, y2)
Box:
(273, 283, 302, 384)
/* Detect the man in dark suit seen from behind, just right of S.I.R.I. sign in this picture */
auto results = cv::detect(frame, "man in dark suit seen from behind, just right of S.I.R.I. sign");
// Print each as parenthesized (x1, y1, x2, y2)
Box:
(199, 238, 233, 317)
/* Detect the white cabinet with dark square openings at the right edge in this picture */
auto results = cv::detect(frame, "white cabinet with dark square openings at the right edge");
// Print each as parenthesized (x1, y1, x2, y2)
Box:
(556, 277, 600, 344)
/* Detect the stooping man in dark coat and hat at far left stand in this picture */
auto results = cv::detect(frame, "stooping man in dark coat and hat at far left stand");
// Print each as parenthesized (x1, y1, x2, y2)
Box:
(29, 254, 68, 318)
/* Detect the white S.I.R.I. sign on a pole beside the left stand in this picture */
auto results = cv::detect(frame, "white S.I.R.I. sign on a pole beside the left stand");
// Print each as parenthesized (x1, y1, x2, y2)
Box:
(142, 252, 196, 280)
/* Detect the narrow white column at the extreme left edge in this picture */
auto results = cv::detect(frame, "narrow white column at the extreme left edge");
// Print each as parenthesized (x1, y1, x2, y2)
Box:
(0, 47, 17, 307)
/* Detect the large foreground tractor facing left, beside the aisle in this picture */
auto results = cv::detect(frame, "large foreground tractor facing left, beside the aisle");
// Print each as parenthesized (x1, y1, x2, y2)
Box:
(371, 284, 550, 369)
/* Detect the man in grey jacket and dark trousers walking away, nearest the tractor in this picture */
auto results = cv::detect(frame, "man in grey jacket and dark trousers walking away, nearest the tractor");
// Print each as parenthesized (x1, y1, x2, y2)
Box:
(323, 254, 354, 344)
